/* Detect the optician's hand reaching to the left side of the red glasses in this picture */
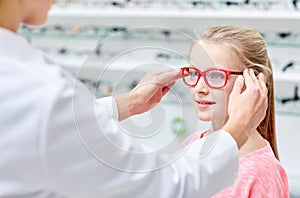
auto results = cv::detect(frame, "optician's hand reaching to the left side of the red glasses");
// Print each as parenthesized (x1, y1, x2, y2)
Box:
(114, 69, 181, 121)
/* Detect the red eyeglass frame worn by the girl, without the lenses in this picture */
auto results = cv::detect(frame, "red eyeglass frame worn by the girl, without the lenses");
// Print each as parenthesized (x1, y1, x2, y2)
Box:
(181, 66, 243, 89)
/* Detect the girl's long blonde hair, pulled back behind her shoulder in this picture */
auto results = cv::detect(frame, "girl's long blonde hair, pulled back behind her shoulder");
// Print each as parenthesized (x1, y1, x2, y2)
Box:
(195, 26, 279, 159)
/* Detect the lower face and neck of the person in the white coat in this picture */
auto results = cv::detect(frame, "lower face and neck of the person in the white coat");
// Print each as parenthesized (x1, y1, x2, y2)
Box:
(20, 0, 56, 25)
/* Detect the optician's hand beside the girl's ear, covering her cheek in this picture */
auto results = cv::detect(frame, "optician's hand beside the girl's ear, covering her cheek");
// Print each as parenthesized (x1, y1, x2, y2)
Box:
(223, 69, 268, 148)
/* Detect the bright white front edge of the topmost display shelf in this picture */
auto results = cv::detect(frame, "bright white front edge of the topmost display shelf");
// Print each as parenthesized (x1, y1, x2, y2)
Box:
(49, 8, 300, 20)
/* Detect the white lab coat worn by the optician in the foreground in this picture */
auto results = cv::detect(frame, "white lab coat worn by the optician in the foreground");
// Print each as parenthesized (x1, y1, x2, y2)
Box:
(0, 28, 238, 198)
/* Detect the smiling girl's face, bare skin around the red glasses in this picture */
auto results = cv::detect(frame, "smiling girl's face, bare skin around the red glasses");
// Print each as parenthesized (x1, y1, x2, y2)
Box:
(190, 41, 242, 127)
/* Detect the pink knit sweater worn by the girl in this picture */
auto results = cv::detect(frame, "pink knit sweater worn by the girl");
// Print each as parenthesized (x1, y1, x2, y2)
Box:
(185, 133, 289, 198)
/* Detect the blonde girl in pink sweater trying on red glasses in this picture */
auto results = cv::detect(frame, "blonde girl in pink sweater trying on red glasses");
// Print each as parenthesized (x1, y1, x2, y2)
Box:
(182, 26, 289, 198)
